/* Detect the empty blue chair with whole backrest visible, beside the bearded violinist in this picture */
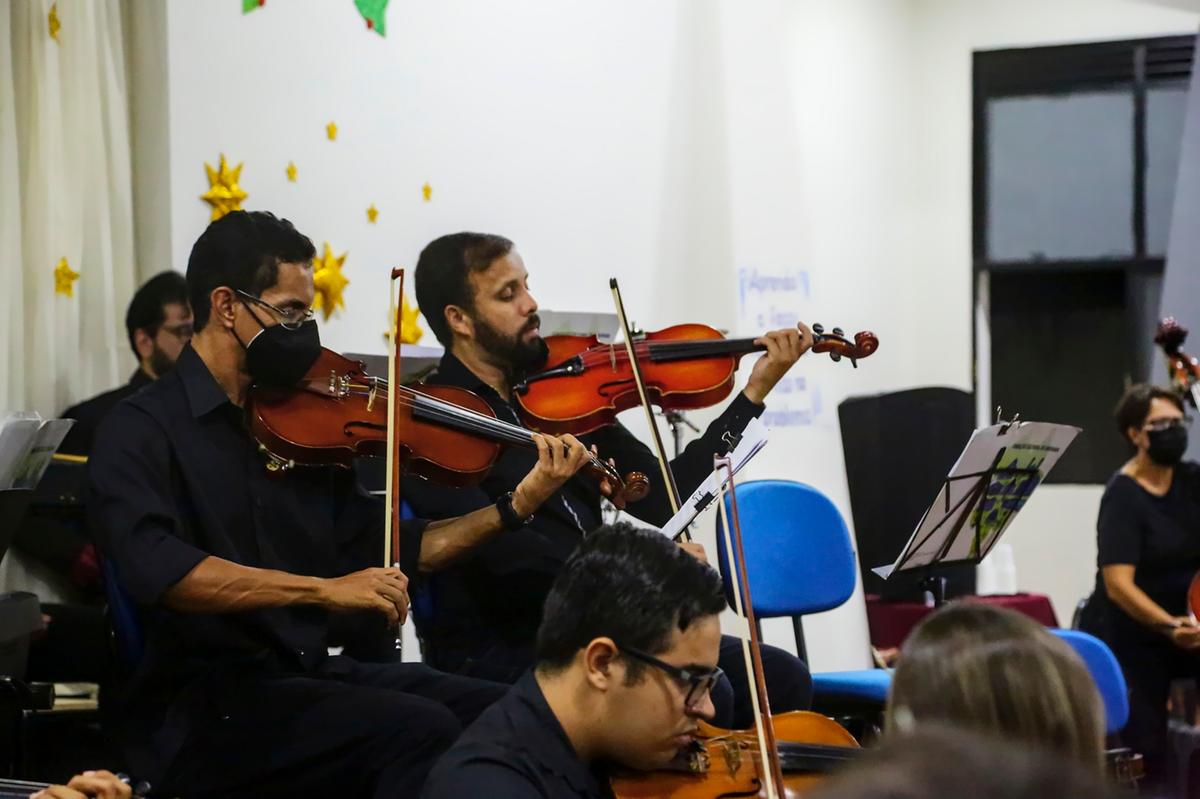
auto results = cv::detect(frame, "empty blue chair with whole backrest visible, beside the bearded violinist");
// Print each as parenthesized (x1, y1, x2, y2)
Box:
(716, 480, 892, 710)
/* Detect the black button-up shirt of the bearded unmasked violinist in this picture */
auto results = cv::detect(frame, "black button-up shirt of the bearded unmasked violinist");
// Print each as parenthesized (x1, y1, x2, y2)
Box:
(402, 353, 763, 667)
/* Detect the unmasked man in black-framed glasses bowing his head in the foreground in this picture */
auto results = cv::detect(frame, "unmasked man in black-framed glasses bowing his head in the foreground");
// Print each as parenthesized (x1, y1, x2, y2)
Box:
(421, 523, 725, 799)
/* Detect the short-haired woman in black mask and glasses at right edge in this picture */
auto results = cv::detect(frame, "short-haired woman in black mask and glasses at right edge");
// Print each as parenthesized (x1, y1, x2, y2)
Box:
(1081, 384, 1200, 786)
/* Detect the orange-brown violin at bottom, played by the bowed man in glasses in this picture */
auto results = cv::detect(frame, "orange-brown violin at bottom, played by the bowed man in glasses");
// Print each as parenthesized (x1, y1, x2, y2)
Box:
(611, 710, 859, 799)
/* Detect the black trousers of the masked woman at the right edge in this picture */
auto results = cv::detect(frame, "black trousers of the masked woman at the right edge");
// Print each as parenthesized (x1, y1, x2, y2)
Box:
(1109, 639, 1200, 788)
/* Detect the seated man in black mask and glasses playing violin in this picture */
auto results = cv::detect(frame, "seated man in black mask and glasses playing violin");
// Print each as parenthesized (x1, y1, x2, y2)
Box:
(88, 211, 600, 799)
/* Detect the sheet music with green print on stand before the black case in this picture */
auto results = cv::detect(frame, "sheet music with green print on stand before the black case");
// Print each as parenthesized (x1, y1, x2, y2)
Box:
(871, 422, 1079, 579)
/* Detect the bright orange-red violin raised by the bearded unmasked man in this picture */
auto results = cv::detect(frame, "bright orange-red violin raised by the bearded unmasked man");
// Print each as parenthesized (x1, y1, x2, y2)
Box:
(514, 324, 880, 435)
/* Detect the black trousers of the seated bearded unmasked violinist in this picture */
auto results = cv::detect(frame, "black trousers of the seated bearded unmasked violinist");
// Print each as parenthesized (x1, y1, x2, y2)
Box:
(425, 636, 812, 729)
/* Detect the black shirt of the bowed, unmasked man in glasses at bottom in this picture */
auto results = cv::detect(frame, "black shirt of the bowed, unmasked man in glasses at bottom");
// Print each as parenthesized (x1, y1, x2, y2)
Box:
(421, 672, 612, 799)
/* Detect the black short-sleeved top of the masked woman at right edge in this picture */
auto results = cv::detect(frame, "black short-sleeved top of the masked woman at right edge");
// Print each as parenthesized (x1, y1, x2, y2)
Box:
(1096, 461, 1200, 641)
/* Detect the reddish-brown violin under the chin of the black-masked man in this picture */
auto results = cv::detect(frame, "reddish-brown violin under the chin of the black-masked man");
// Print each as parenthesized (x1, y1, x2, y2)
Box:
(246, 349, 649, 507)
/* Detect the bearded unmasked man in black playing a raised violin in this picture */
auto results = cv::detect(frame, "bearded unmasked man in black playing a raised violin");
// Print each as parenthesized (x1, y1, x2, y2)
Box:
(403, 233, 812, 727)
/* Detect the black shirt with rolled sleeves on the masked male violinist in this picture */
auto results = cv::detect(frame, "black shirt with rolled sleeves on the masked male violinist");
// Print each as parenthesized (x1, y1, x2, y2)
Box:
(88, 346, 424, 765)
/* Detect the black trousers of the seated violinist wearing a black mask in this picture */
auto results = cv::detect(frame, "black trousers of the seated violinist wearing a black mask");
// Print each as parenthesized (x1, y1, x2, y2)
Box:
(154, 657, 508, 799)
